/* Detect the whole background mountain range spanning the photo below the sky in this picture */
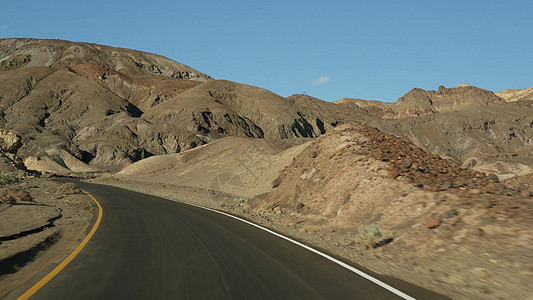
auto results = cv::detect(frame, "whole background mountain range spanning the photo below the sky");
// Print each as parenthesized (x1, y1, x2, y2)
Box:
(0, 39, 533, 178)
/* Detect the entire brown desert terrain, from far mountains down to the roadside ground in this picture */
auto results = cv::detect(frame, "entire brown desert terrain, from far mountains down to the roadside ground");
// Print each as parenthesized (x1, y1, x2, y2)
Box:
(0, 39, 533, 299)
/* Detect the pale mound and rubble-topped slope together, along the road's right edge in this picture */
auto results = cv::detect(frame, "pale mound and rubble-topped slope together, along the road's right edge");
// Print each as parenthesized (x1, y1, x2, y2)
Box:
(98, 125, 533, 299)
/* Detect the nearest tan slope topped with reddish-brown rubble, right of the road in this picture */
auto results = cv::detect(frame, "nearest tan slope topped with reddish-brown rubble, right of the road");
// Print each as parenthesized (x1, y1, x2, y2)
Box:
(262, 125, 533, 299)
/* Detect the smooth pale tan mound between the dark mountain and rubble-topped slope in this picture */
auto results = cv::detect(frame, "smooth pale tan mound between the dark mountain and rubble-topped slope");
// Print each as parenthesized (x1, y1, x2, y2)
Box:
(115, 137, 307, 197)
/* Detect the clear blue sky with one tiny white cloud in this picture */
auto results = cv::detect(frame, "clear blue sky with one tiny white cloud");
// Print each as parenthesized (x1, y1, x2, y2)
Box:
(0, 0, 533, 101)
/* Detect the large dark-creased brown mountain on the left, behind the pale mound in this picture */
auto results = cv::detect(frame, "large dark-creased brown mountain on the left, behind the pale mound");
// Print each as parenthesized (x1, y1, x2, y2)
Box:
(0, 39, 365, 173)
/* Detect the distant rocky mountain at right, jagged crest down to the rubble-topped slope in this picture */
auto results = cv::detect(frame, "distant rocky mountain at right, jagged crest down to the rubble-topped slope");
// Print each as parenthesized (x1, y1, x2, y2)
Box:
(335, 84, 533, 178)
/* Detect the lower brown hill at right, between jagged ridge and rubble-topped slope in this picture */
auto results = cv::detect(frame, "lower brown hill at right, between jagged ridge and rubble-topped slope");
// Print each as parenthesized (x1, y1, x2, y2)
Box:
(368, 101, 533, 178)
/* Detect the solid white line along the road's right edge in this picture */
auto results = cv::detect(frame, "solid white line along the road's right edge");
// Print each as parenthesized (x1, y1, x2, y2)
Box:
(163, 197, 415, 300)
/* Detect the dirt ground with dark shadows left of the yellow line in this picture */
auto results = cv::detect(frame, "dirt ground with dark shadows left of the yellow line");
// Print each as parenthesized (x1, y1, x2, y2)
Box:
(0, 178, 93, 299)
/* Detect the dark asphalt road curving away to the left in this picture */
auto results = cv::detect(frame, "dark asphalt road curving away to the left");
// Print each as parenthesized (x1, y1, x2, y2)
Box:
(20, 179, 444, 299)
